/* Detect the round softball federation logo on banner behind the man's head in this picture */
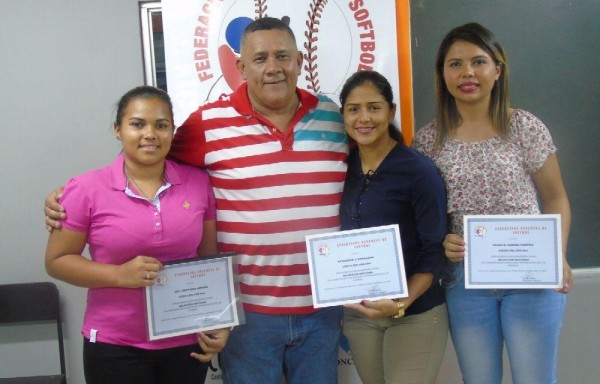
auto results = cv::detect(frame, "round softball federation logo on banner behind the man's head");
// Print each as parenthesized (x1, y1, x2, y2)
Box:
(194, 0, 382, 100)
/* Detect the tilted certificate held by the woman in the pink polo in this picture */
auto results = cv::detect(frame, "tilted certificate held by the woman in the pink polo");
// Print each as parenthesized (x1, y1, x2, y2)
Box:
(146, 254, 239, 340)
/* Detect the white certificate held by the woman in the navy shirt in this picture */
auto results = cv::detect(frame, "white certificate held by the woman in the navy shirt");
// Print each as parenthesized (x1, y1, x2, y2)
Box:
(306, 225, 408, 308)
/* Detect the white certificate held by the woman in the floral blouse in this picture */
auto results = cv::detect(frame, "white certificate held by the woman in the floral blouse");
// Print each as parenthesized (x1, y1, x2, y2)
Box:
(464, 215, 563, 289)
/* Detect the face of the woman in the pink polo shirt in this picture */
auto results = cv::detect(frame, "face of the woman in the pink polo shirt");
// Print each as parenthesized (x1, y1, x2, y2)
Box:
(114, 97, 173, 166)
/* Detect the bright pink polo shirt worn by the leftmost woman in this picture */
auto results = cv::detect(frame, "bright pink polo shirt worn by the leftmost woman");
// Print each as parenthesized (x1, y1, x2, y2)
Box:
(61, 155, 216, 349)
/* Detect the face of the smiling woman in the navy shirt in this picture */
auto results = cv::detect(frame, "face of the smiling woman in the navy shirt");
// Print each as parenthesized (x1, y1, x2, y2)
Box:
(342, 82, 395, 147)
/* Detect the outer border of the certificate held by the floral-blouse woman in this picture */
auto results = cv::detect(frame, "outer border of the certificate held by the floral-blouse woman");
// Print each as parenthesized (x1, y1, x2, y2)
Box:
(463, 214, 563, 289)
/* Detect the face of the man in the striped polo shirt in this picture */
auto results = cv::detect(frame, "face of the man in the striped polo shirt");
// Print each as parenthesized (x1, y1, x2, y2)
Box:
(237, 29, 302, 111)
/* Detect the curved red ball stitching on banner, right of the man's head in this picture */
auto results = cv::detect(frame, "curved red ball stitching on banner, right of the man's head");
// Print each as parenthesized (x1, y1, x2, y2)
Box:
(304, 0, 327, 93)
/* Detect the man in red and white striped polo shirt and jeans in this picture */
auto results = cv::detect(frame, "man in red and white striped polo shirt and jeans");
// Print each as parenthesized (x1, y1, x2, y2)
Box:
(170, 18, 348, 384)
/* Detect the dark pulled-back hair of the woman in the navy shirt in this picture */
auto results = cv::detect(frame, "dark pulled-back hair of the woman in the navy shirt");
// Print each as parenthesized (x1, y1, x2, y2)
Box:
(340, 71, 404, 144)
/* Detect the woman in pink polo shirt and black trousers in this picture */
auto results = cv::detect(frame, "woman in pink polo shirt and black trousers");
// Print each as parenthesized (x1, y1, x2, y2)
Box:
(46, 86, 229, 384)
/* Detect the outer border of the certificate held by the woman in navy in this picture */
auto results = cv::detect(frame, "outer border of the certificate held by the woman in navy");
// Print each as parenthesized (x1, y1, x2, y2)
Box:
(306, 224, 408, 308)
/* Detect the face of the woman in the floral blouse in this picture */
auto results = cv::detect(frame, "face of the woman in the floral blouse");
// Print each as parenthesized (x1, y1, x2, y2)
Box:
(444, 40, 500, 108)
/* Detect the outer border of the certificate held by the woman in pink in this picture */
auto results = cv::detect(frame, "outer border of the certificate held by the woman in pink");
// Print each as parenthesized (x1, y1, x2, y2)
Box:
(145, 253, 240, 341)
